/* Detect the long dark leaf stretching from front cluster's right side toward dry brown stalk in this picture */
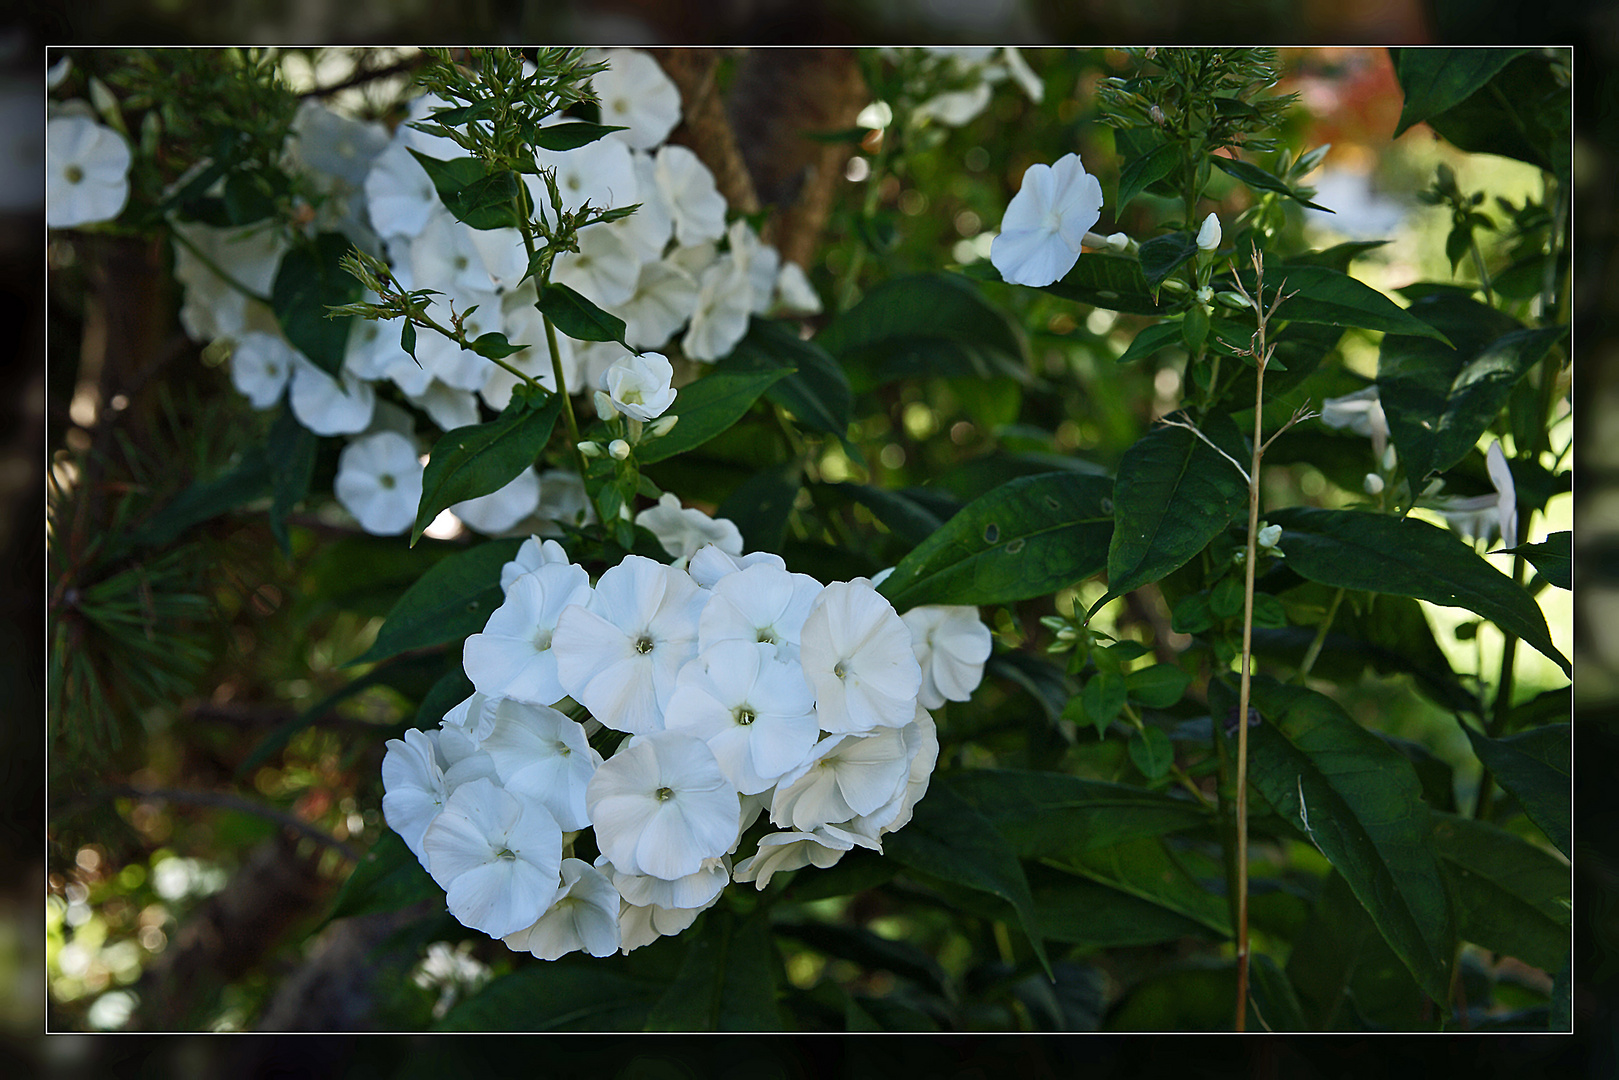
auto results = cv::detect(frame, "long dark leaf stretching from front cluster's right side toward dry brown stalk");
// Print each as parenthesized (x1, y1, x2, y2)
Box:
(945, 769, 1211, 860)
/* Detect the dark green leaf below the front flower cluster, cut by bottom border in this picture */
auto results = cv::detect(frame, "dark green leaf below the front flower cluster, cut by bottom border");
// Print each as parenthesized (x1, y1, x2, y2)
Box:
(646, 907, 782, 1031)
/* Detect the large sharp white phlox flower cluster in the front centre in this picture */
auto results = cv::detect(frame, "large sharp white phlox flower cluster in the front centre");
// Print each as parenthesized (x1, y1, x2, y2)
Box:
(382, 538, 991, 960)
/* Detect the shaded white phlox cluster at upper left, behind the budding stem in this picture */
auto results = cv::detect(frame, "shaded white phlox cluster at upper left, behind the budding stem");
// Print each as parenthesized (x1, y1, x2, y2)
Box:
(159, 49, 821, 534)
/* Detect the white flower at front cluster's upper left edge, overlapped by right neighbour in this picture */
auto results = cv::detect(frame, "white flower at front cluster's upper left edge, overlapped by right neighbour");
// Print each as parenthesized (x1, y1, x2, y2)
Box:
(461, 562, 591, 709)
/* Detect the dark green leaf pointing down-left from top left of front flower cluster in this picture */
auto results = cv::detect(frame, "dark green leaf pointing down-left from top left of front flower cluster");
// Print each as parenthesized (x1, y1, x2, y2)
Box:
(353, 539, 521, 664)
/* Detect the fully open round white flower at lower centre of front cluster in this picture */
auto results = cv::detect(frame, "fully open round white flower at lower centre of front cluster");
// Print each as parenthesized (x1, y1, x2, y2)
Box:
(584, 732, 740, 881)
